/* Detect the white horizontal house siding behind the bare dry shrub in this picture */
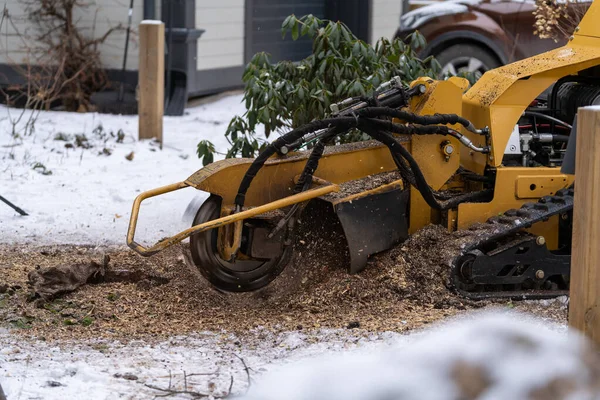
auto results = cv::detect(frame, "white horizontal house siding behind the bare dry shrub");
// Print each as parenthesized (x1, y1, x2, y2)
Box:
(0, 0, 143, 70)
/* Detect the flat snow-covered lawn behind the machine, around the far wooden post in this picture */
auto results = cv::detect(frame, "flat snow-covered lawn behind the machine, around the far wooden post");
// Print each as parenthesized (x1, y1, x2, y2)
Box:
(0, 95, 255, 245)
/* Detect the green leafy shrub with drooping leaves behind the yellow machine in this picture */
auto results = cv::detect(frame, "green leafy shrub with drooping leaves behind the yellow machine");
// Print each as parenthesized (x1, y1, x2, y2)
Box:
(197, 15, 441, 165)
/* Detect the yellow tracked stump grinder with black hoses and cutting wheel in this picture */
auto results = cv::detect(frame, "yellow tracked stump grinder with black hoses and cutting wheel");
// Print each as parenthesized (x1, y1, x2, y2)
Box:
(127, 1, 600, 299)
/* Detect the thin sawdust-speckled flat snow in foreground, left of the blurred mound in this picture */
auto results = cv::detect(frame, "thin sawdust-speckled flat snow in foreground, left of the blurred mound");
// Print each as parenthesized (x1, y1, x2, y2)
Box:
(0, 329, 409, 400)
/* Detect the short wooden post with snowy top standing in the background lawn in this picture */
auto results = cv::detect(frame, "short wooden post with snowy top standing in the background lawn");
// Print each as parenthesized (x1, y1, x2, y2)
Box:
(138, 20, 165, 145)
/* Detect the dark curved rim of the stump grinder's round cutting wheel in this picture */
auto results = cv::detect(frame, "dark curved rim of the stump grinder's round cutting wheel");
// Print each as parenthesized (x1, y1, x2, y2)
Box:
(190, 195, 292, 292)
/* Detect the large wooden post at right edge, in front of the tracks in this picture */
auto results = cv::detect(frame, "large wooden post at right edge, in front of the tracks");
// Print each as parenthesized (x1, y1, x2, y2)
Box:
(569, 107, 600, 344)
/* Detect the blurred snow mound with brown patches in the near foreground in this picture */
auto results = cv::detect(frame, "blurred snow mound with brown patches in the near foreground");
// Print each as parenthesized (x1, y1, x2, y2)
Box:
(247, 313, 600, 400)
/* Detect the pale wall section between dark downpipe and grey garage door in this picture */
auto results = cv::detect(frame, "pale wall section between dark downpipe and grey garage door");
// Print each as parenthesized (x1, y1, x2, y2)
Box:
(196, 0, 245, 70)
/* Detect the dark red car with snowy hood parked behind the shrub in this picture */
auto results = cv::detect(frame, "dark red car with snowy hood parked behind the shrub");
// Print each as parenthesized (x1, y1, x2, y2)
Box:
(396, 0, 589, 75)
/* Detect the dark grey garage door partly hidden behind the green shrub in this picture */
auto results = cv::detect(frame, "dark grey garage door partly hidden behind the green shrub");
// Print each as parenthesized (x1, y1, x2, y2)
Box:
(245, 0, 326, 62)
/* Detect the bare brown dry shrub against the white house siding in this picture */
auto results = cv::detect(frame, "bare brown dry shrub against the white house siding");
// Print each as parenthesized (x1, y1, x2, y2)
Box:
(4, 0, 122, 112)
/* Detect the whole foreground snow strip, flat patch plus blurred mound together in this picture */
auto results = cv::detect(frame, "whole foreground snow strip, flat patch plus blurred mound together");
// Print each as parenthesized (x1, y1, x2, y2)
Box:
(0, 311, 600, 400)
